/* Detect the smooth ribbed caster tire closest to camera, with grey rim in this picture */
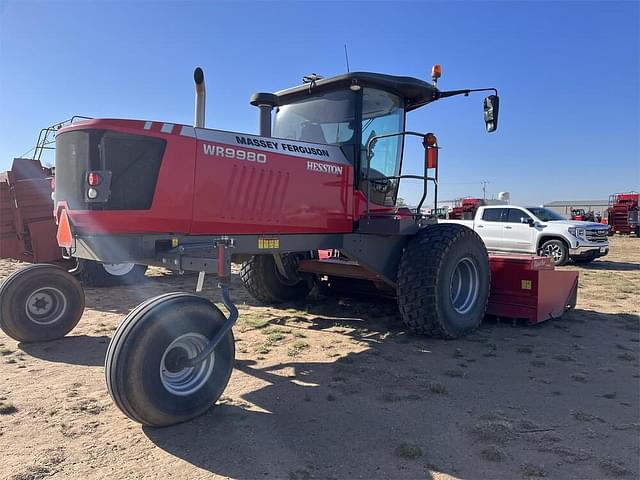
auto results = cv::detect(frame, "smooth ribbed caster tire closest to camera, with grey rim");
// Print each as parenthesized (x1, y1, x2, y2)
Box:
(105, 293, 235, 427)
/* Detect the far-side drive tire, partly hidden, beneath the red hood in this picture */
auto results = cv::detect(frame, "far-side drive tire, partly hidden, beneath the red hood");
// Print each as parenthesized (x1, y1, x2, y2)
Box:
(240, 253, 311, 303)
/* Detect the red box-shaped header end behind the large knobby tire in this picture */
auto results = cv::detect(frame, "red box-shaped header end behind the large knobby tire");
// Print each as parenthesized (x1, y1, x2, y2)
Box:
(487, 254, 578, 324)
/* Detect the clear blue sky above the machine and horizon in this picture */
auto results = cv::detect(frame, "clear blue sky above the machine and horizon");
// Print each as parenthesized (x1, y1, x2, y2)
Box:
(0, 0, 640, 204)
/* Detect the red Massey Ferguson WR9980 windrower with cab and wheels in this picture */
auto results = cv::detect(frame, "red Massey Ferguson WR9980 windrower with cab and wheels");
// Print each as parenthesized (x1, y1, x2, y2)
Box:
(0, 66, 510, 426)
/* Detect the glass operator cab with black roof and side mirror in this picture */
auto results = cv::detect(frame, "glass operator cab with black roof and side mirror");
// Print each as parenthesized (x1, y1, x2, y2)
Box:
(251, 70, 497, 212)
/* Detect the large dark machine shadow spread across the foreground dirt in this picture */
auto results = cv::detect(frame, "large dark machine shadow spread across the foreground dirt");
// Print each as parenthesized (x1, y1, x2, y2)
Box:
(143, 310, 640, 479)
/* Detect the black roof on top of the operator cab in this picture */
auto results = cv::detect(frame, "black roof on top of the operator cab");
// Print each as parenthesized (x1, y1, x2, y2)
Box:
(251, 72, 440, 111)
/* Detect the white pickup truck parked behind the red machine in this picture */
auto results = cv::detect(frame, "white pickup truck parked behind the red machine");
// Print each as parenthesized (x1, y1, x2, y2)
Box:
(438, 205, 609, 265)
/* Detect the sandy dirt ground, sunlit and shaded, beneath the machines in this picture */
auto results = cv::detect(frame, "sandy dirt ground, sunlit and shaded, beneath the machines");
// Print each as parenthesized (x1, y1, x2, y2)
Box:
(0, 237, 640, 480)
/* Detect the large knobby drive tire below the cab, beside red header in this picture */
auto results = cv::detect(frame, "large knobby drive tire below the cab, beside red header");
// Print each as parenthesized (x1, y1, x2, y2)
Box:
(397, 224, 491, 339)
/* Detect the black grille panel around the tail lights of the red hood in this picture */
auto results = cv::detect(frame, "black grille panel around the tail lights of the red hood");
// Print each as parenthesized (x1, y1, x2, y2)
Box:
(56, 130, 166, 210)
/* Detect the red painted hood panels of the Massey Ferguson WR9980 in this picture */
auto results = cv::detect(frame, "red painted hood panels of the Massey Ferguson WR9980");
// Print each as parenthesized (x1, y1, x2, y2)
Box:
(57, 119, 394, 235)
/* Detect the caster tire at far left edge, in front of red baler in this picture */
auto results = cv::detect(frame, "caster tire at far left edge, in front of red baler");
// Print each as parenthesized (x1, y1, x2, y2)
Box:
(0, 264, 84, 342)
